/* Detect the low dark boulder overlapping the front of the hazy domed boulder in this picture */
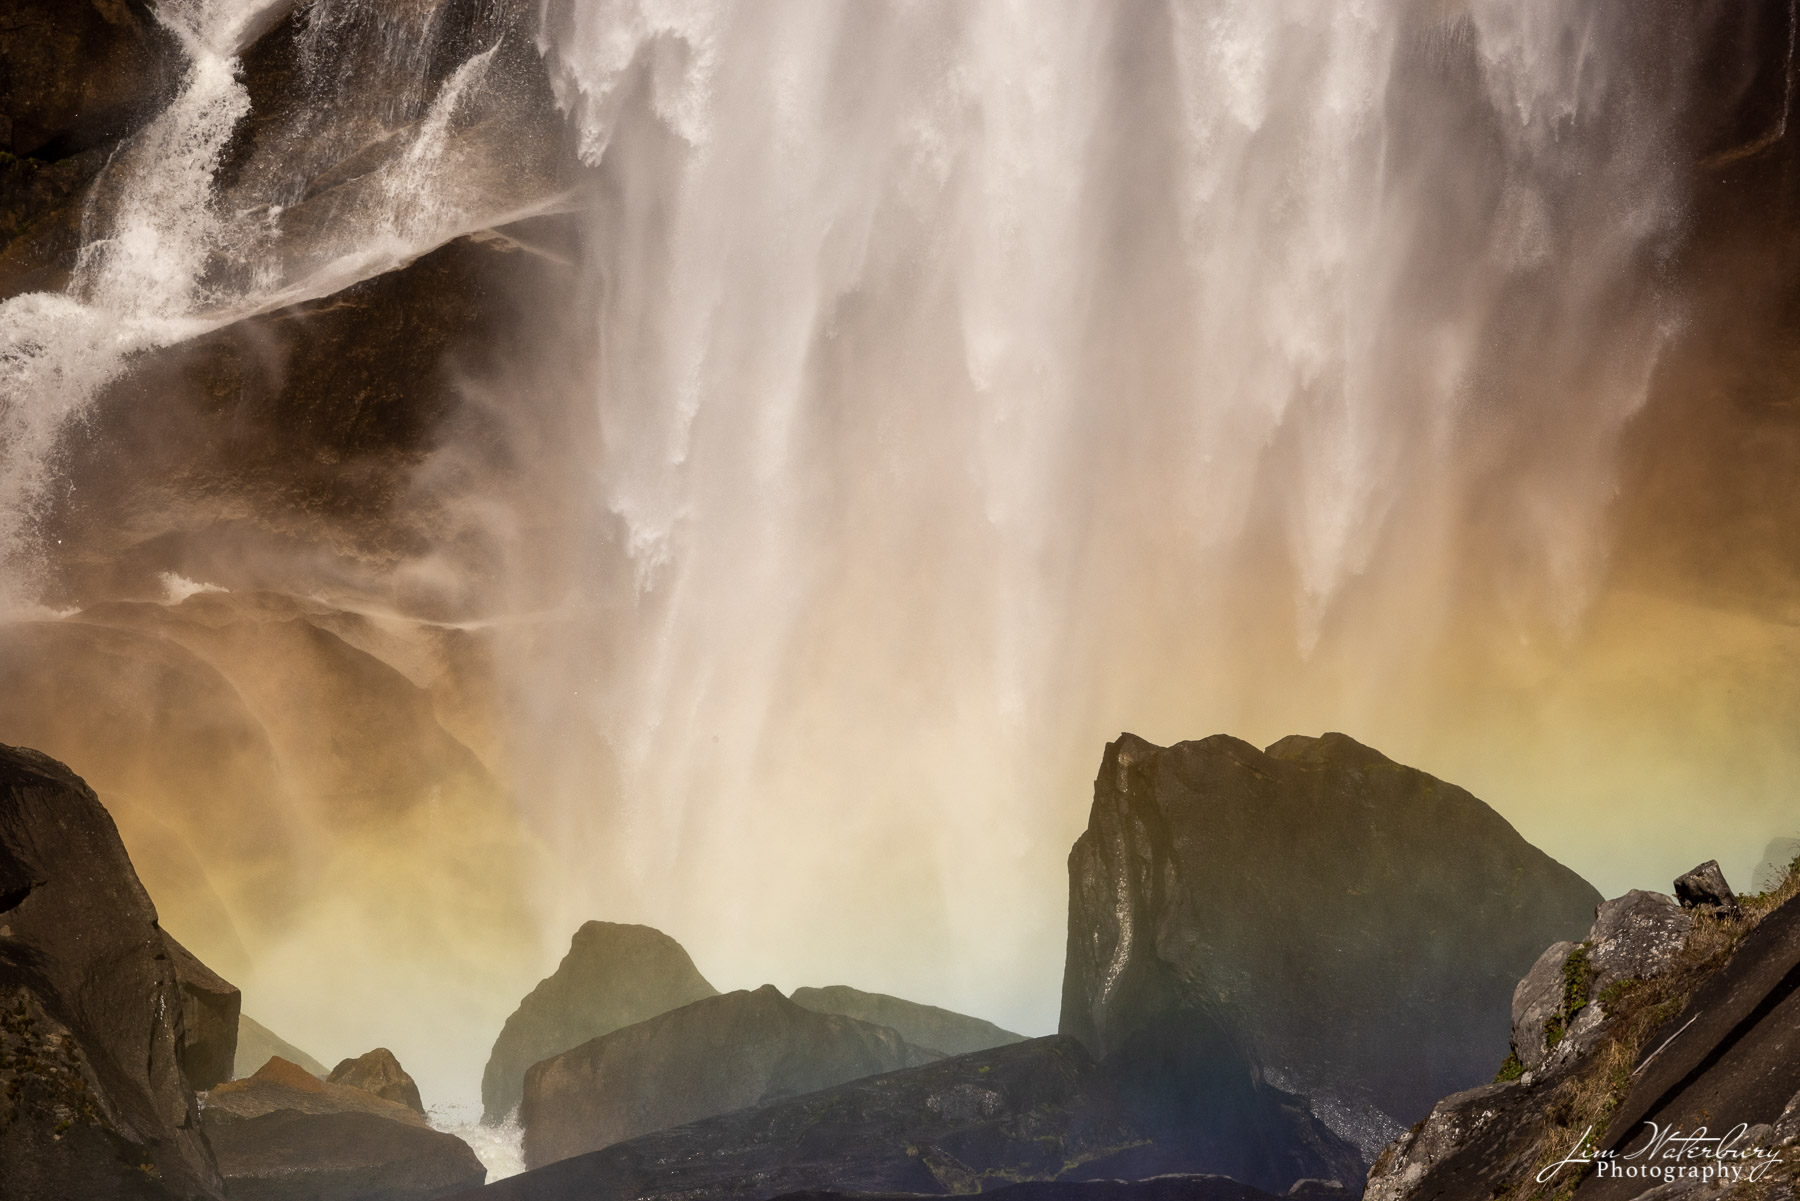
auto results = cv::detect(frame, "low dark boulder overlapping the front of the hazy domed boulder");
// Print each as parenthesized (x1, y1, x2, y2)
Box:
(518, 985, 940, 1167)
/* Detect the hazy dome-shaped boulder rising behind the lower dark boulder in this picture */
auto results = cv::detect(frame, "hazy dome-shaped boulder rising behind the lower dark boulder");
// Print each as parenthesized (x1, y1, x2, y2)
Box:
(481, 922, 718, 1122)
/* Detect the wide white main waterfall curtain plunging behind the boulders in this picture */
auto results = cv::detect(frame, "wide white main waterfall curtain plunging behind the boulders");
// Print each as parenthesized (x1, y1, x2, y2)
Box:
(502, 0, 1681, 1030)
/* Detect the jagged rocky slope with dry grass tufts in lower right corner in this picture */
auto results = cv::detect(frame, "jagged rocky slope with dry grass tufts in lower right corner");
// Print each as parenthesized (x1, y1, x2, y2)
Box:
(1364, 864, 1800, 1201)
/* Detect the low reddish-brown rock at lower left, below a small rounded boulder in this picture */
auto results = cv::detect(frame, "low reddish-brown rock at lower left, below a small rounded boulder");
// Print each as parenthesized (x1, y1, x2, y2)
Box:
(205, 1059, 486, 1201)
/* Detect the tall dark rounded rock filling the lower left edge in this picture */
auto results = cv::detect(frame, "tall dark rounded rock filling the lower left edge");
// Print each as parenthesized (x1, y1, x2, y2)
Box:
(0, 747, 221, 1199)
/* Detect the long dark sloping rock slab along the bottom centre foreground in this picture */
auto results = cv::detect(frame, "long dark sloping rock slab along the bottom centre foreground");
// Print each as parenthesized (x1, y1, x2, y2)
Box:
(446, 1037, 1361, 1201)
